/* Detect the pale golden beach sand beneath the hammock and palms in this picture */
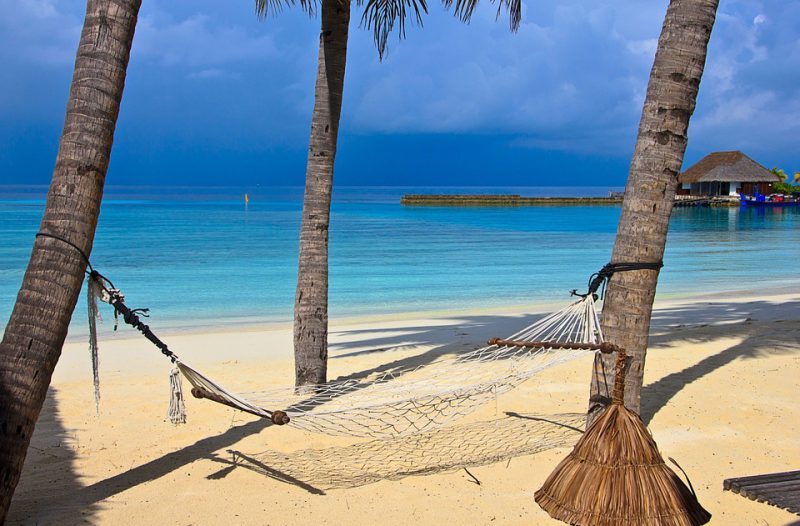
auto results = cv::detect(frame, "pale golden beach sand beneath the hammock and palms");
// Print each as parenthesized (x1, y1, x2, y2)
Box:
(8, 291, 800, 525)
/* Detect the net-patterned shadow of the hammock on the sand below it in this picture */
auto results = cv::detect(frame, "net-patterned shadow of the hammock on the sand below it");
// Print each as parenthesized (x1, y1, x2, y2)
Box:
(205, 413, 585, 495)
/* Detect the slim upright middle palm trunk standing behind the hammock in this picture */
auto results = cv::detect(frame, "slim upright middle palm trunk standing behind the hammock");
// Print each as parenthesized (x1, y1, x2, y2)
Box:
(294, 0, 350, 386)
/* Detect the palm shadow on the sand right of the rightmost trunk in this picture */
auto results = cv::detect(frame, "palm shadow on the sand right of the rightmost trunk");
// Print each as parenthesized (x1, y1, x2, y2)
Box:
(641, 301, 800, 424)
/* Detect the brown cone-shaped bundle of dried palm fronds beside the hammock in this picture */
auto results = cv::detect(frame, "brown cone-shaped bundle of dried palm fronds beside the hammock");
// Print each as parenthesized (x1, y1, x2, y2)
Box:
(535, 349, 711, 526)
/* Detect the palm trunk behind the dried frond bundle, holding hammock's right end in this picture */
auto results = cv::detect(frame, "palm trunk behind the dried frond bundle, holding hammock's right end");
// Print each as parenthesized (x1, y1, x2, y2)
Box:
(589, 0, 719, 422)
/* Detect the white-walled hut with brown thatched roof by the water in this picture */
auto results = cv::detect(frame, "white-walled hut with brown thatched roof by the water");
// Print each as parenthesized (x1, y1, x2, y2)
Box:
(678, 151, 780, 195)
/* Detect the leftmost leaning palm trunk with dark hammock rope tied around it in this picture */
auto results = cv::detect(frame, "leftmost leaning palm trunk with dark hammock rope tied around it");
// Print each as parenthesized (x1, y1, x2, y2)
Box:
(0, 0, 141, 523)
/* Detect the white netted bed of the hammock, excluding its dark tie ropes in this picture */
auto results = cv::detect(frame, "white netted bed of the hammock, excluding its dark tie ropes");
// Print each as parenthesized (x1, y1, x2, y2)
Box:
(176, 295, 603, 438)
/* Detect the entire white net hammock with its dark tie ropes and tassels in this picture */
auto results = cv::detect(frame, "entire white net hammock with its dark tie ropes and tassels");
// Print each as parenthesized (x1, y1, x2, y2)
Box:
(32, 233, 662, 438)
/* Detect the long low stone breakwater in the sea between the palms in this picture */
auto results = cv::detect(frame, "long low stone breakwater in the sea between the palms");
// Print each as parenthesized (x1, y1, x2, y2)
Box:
(400, 194, 622, 206)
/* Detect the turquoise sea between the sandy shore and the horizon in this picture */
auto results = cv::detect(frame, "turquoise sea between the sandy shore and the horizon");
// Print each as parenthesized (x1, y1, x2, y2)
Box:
(0, 186, 800, 333)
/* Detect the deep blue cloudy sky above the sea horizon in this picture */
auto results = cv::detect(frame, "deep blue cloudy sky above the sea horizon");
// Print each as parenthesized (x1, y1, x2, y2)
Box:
(0, 0, 800, 186)
